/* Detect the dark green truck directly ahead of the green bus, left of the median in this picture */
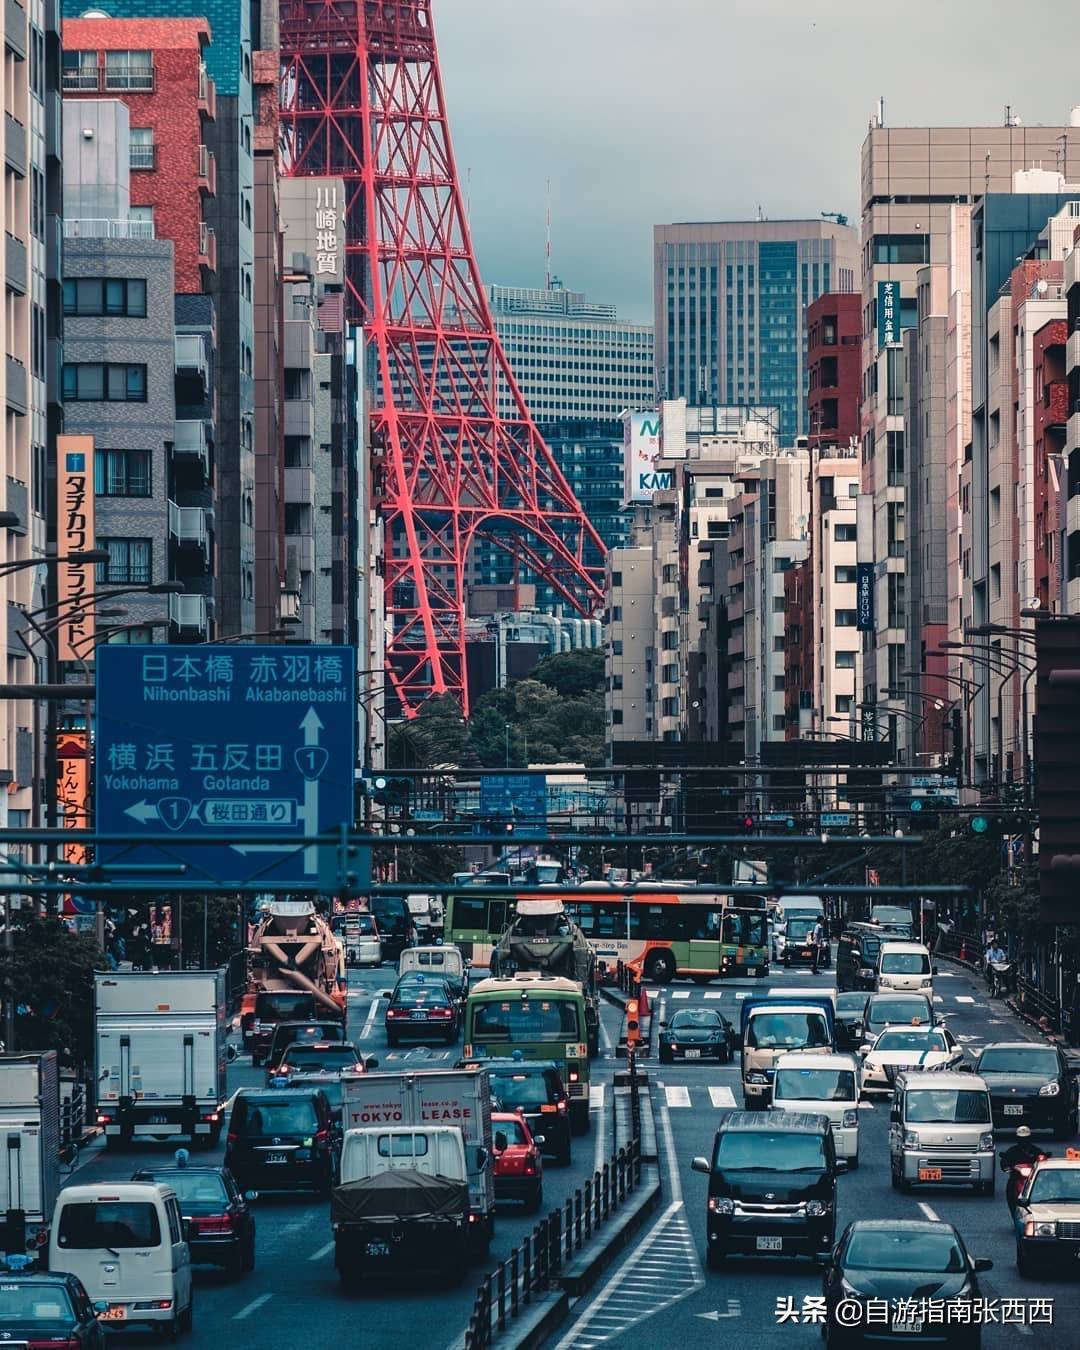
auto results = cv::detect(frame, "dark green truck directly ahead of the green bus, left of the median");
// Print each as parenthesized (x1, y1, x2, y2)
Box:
(490, 895, 599, 1056)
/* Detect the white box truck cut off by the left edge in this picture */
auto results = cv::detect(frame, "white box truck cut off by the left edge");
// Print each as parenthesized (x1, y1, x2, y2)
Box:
(0, 1050, 59, 1268)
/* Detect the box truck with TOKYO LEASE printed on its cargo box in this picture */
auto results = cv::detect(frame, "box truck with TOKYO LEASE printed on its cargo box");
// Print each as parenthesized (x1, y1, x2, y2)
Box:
(342, 1068, 495, 1250)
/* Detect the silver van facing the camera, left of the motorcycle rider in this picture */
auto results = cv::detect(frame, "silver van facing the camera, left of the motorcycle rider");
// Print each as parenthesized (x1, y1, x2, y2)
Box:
(888, 1071, 995, 1195)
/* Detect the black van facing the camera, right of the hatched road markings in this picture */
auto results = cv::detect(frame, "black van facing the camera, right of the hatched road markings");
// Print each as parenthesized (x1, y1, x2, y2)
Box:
(693, 1111, 844, 1270)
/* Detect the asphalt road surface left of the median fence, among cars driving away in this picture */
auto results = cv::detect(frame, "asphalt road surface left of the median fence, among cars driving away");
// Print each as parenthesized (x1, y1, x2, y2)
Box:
(59, 967, 629, 1350)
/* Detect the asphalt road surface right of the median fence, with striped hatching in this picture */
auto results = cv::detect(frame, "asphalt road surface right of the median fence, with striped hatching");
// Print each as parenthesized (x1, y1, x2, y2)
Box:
(547, 963, 1080, 1350)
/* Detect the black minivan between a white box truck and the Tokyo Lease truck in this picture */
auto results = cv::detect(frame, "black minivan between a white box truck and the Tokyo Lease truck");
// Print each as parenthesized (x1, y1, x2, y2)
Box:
(225, 1088, 340, 1195)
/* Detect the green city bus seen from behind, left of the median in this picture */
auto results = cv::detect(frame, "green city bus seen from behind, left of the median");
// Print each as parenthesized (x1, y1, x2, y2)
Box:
(463, 971, 589, 1134)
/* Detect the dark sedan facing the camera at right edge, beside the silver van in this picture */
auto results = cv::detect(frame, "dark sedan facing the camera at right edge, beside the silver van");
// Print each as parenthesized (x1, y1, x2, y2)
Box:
(975, 1041, 1077, 1139)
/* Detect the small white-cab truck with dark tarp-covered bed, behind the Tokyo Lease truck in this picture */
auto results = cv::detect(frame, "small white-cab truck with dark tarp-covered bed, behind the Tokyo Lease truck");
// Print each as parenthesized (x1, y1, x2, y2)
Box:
(329, 1125, 475, 1289)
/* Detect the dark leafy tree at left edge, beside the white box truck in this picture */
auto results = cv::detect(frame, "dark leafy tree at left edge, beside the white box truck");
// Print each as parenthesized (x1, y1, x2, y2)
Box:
(0, 910, 105, 1065)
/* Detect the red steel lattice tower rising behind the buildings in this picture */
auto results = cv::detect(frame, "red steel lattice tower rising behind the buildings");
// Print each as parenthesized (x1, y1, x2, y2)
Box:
(279, 0, 605, 717)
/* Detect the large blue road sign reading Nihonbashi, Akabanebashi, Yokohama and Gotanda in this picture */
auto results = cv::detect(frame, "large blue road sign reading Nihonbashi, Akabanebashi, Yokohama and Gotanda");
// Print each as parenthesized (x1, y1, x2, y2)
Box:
(95, 644, 356, 890)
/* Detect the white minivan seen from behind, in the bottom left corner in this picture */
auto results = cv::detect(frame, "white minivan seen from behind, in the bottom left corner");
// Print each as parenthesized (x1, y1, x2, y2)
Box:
(49, 1181, 192, 1339)
